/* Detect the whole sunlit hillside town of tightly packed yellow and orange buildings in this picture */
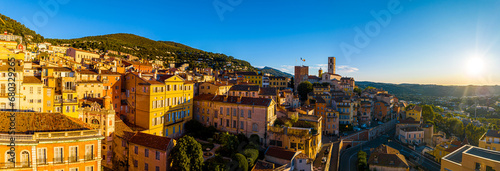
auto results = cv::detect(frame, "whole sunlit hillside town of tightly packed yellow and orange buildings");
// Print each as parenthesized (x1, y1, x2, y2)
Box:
(0, 28, 500, 171)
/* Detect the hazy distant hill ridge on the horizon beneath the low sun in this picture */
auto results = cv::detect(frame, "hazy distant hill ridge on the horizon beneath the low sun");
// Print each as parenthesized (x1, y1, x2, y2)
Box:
(356, 81, 500, 97)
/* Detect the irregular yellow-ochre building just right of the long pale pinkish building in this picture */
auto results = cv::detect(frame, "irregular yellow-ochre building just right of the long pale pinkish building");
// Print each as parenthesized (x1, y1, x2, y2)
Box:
(267, 112, 323, 159)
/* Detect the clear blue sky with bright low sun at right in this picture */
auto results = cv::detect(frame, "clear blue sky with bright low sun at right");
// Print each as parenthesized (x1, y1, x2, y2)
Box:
(0, 0, 500, 85)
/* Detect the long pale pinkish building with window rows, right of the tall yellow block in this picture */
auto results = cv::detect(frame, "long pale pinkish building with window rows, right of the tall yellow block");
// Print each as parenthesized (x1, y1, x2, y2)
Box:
(194, 94, 277, 143)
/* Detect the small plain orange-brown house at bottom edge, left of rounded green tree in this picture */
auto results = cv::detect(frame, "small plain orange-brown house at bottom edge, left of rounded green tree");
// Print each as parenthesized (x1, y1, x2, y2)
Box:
(127, 132, 175, 171)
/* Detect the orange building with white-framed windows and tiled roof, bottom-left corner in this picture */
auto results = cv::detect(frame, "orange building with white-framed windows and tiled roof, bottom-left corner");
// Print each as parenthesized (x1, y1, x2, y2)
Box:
(0, 112, 104, 171)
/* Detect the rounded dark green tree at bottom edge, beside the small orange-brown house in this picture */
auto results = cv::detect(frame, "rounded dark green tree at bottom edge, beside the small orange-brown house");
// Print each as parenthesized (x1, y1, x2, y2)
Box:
(170, 136, 203, 171)
